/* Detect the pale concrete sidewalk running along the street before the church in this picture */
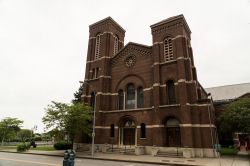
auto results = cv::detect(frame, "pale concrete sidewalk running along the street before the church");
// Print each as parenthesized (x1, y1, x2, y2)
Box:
(0, 150, 250, 166)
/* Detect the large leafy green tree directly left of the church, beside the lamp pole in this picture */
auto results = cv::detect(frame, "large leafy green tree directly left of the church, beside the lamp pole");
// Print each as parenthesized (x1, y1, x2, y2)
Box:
(43, 102, 92, 142)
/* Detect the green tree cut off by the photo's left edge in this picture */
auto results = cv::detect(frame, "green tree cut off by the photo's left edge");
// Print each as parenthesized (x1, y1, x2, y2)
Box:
(0, 117, 23, 145)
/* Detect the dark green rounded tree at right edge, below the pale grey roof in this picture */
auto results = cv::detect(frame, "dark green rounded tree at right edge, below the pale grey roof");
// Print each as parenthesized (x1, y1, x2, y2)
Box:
(219, 98, 250, 134)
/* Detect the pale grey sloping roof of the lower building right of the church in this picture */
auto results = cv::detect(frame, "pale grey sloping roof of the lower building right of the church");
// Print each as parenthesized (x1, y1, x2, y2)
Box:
(206, 83, 250, 101)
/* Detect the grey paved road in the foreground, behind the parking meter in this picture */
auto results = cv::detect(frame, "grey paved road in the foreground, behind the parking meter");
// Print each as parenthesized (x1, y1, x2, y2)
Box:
(0, 152, 170, 166)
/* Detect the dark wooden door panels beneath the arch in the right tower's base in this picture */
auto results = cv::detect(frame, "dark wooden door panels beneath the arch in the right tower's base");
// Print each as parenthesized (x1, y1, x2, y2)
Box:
(167, 127, 181, 147)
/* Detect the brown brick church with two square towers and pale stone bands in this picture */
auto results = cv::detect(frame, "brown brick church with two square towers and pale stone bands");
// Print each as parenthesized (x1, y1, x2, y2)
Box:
(82, 15, 216, 157)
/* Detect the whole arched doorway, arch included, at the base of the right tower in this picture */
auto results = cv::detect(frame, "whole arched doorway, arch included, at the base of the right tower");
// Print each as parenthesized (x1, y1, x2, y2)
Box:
(165, 118, 181, 147)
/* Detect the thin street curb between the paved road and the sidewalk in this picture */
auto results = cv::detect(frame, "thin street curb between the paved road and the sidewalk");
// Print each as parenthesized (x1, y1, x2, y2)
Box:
(0, 150, 202, 166)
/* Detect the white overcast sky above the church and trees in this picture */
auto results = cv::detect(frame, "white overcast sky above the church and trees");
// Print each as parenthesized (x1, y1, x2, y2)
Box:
(0, 0, 250, 132)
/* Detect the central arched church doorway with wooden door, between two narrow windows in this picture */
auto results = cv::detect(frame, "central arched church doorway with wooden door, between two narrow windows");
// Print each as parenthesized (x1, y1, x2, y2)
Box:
(120, 120, 136, 145)
